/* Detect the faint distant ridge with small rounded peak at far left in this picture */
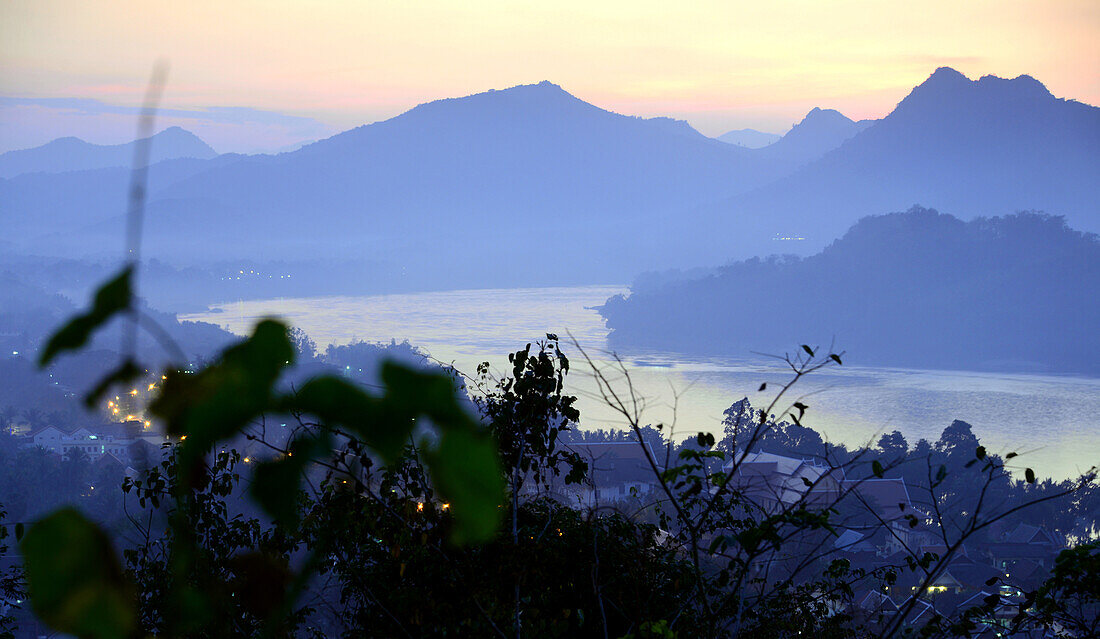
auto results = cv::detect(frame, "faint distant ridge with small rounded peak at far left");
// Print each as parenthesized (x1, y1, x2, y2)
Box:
(0, 126, 218, 177)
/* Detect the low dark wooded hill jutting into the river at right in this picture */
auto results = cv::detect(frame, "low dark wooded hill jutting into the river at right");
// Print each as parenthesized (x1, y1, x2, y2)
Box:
(601, 208, 1100, 374)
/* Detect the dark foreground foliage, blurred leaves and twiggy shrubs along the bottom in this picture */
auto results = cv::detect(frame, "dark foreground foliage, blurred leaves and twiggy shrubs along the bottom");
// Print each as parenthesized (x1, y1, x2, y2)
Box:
(0, 265, 1097, 638)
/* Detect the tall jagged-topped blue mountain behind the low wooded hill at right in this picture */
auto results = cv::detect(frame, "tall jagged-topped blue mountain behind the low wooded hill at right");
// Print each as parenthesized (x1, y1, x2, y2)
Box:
(699, 67, 1100, 256)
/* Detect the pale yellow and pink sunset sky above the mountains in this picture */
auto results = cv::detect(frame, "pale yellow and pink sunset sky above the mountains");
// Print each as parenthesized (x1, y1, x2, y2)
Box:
(0, 0, 1100, 152)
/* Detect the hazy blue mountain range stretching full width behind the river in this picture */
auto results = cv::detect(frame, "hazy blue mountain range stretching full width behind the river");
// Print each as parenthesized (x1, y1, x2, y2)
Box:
(0, 68, 1100, 288)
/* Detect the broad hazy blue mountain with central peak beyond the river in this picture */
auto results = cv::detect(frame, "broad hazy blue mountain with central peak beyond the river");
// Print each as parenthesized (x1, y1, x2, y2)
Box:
(0, 82, 792, 286)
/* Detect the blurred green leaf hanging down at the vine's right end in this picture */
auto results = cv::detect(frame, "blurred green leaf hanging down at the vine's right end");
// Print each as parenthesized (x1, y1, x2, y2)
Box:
(428, 429, 504, 543)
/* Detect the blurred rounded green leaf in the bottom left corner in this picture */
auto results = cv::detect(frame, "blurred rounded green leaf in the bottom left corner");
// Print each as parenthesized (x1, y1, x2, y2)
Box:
(20, 508, 138, 639)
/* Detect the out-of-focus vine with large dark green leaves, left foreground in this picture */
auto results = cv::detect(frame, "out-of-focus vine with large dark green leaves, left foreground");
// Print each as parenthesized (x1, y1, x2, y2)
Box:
(22, 265, 503, 637)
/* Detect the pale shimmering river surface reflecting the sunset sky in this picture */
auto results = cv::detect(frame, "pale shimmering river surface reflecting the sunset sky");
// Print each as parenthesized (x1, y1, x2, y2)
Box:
(180, 286, 1100, 477)
